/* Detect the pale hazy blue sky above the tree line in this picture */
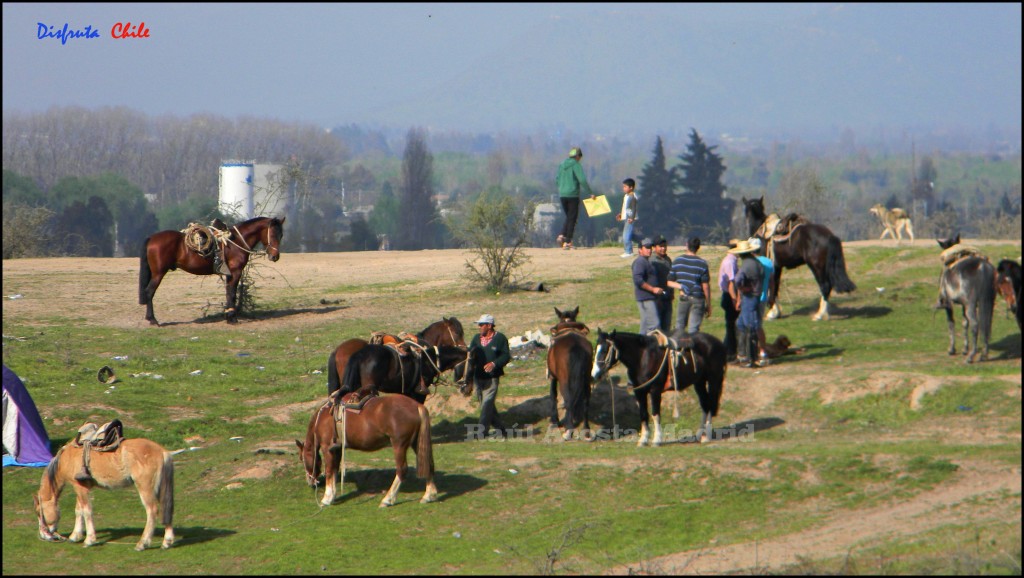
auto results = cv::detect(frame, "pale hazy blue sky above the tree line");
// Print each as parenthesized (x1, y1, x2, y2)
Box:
(3, 3, 1021, 139)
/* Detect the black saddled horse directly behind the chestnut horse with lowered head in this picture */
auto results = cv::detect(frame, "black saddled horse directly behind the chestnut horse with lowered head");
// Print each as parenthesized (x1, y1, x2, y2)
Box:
(332, 341, 467, 404)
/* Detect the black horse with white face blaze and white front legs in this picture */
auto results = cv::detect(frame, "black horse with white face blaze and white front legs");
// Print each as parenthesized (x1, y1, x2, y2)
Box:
(591, 329, 726, 446)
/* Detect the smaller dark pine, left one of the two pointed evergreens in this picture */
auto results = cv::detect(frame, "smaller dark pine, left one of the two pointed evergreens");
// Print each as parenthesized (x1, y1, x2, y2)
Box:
(636, 136, 680, 239)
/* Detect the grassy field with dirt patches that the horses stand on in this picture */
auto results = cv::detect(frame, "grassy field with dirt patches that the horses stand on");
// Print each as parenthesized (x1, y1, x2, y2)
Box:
(3, 234, 1021, 575)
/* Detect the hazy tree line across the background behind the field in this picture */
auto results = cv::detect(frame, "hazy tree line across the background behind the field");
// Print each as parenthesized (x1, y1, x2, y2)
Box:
(3, 107, 1021, 257)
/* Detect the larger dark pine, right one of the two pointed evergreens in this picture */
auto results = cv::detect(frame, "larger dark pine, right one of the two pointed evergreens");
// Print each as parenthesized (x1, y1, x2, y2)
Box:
(673, 129, 735, 243)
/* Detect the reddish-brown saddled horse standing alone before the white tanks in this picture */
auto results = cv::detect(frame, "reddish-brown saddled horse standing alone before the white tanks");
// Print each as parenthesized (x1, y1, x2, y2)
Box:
(138, 217, 285, 325)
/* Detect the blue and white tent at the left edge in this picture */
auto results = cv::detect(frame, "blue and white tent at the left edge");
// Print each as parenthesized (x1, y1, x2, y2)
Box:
(3, 365, 53, 467)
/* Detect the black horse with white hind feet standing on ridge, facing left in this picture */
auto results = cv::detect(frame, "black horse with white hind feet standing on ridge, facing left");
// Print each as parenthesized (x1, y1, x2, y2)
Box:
(743, 197, 857, 321)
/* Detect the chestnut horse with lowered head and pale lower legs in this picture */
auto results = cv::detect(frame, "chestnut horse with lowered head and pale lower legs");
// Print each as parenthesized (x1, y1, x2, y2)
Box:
(295, 396, 437, 507)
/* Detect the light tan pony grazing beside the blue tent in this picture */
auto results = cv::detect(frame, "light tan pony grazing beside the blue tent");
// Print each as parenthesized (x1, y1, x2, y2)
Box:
(32, 438, 174, 551)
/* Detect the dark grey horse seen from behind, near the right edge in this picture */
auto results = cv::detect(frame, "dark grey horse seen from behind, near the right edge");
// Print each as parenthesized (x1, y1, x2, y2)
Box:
(935, 234, 995, 363)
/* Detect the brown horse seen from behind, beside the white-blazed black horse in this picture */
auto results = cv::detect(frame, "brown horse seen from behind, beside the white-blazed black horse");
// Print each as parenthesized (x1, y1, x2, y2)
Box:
(547, 307, 594, 440)
